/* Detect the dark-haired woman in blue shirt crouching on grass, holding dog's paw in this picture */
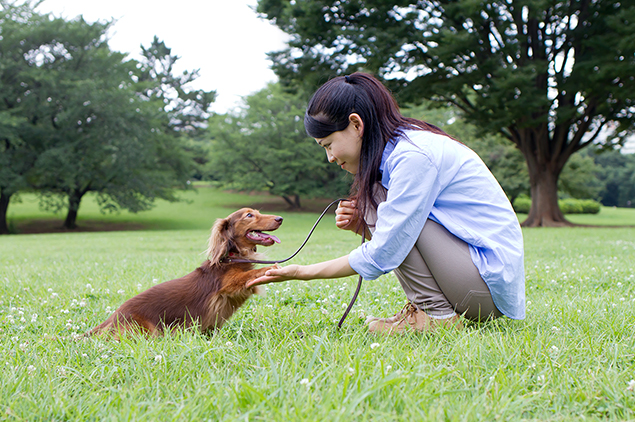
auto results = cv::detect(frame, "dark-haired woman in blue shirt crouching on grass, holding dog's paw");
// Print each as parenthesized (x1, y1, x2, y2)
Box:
(251, 73, 525, 333)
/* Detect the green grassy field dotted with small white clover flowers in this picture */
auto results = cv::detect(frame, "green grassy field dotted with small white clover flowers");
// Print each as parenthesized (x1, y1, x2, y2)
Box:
(0, 189, 635, 421)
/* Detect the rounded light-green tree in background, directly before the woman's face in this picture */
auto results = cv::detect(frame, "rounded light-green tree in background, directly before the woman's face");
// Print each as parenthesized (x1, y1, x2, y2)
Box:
(209, 84, 348, 208)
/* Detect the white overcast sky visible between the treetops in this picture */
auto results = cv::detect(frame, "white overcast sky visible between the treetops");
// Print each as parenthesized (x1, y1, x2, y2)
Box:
(37, 0, 287, 113)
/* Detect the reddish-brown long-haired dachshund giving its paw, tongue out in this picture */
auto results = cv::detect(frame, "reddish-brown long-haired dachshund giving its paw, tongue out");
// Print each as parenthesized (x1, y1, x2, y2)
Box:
(87, 208, 282, 336)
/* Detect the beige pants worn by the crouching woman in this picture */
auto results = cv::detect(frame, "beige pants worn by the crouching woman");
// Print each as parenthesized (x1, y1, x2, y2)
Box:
(366, 190, 502, 321)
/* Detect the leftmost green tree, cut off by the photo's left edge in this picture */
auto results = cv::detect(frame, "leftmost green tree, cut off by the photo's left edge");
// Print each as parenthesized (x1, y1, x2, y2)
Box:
(0, 0, 63, 234)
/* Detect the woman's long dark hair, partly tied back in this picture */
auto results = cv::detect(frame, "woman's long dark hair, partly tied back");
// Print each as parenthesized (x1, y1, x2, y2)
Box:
(304, 73, 450, 227)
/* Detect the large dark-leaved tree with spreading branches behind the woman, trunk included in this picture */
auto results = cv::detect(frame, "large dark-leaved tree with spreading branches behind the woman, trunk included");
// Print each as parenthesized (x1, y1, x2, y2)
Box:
(258, 0, 635, 226)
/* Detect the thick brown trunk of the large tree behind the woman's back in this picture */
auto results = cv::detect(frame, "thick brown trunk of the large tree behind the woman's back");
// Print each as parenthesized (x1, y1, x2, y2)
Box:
(521, 157, 573, 227)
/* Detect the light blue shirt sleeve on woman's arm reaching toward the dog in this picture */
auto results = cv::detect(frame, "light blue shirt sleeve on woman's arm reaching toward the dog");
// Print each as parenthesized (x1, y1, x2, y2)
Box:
(348, 150, 441, 280)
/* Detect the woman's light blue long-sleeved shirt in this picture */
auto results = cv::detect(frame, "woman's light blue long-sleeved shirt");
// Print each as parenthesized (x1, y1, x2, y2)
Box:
(348, 130, 525, 319)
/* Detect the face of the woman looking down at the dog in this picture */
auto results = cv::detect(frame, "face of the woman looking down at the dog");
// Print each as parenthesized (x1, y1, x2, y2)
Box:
(315, 113, 364, 174)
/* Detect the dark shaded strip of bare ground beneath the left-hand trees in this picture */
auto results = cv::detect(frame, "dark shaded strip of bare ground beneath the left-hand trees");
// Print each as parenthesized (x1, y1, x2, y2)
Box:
(9, 220, 149, 234)
